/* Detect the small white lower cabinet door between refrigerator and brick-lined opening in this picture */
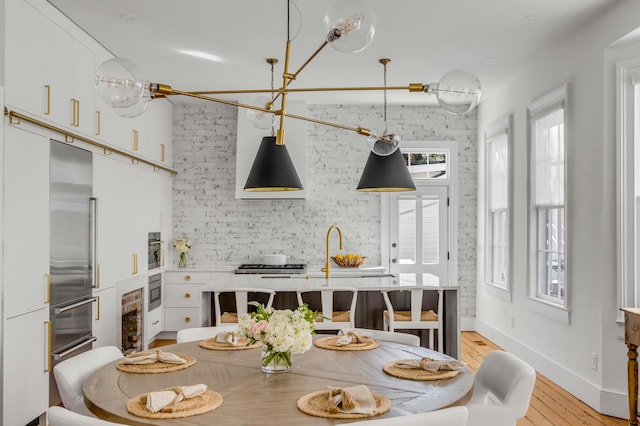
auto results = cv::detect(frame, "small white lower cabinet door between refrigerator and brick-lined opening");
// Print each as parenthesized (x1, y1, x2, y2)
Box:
(93, 286, 120, 348)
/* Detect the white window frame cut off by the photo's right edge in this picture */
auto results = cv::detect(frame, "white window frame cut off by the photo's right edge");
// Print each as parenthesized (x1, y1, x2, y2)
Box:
(616, 59, 640, 323)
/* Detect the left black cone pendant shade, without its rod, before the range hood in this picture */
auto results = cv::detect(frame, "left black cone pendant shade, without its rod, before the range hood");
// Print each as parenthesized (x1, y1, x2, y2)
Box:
(244, 136, 303, 192)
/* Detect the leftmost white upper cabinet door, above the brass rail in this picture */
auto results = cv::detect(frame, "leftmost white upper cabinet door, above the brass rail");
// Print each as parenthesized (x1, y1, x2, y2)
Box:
(5, 1, 51, 119)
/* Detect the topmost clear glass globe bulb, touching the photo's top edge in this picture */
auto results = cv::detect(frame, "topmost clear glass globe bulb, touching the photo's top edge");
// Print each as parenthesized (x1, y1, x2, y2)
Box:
(322, 0, 377, 53)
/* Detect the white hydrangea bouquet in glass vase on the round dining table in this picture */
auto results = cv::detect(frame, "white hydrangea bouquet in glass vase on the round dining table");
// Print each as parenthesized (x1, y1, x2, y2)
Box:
(238, 302, 318, 372)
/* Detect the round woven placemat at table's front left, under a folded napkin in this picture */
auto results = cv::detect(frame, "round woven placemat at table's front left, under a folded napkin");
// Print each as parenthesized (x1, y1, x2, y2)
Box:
(127, 390, 222, 419)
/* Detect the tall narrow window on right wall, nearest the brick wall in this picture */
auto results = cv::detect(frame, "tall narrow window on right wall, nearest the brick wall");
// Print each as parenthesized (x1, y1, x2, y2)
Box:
(485, 117, 511, 290)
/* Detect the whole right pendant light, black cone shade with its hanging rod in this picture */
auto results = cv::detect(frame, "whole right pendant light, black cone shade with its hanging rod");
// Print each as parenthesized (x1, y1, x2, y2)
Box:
(358, 58, 416, 192)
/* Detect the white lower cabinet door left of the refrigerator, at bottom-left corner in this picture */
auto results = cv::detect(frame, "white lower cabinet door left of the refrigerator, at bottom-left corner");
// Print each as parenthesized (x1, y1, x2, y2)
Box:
(2, 307, 50, 425)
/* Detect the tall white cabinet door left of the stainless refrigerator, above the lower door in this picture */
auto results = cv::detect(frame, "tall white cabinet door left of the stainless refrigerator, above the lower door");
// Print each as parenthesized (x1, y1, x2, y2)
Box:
(4, 126, 49, 318)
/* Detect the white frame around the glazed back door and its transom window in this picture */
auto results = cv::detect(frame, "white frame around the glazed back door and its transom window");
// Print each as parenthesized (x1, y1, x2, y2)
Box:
(380, 141, 458, 285)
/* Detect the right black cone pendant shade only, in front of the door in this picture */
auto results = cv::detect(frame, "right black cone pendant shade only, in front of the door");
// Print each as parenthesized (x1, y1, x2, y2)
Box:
(358, 149, 416, 192)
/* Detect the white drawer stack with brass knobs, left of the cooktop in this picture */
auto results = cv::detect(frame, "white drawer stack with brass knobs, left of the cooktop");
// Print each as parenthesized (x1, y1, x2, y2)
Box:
(163, 272, 211, 331)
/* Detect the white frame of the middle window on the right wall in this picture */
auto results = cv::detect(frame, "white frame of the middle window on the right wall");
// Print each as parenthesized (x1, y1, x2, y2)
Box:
(526, 84, 571, 324)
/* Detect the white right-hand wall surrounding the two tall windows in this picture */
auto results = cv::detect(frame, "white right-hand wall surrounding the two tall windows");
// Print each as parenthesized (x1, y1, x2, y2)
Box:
(476, 0, 640, 417)
